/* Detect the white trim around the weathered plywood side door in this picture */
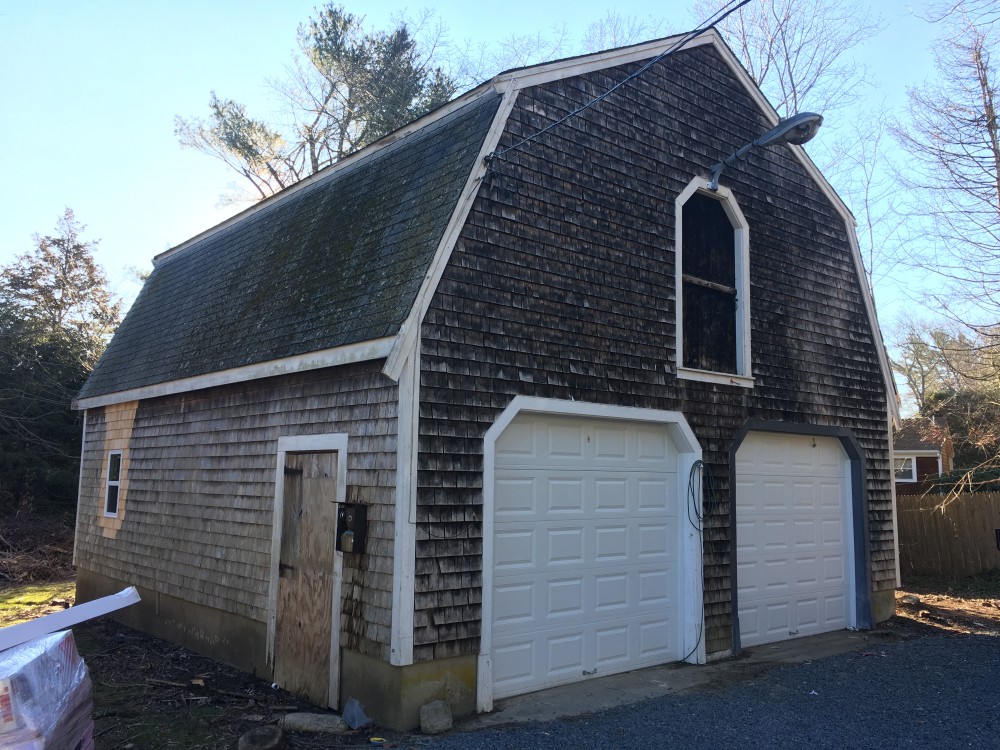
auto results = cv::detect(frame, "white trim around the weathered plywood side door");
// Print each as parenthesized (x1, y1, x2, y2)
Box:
(267, 432, 347, 708)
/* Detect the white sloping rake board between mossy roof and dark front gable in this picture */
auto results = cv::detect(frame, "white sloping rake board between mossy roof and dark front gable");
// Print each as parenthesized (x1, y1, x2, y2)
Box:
(382, 79, 519, 381)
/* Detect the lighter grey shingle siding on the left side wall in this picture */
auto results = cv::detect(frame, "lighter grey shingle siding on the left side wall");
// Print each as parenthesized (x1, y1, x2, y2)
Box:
(77, 361, 397, 659)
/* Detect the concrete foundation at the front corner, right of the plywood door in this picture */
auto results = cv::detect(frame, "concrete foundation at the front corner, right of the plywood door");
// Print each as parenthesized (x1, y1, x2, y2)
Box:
(340, 650, 476, 731)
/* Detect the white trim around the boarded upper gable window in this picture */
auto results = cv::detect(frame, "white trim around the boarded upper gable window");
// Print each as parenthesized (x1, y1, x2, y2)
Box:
(674, 177, 754, 388)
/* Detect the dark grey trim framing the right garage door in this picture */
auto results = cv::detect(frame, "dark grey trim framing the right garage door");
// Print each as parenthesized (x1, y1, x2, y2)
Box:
(729, 419, 875, 656)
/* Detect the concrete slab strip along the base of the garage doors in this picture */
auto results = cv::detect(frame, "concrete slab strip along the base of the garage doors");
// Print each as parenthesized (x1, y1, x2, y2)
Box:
(455, 630, 896, 731)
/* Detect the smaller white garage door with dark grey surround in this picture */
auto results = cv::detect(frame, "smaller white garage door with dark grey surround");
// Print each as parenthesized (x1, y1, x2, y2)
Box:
(736, 432, 850, 646)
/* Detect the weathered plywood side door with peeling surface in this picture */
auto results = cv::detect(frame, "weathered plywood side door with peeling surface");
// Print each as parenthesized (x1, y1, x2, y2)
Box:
(274, 452, 340, 707)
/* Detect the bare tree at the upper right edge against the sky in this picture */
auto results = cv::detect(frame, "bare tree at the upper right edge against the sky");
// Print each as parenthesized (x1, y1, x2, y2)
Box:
(893, 4, 1000, 324)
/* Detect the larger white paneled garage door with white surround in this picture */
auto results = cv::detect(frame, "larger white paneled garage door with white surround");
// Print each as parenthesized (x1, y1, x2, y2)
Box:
(491, 414, 680, 698)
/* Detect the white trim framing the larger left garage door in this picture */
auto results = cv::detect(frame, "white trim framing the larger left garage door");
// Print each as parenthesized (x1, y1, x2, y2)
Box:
(476, 396, 706, 713)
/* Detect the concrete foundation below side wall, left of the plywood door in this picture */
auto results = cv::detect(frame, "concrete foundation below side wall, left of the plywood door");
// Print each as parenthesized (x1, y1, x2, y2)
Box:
(76, 568, 271, 679)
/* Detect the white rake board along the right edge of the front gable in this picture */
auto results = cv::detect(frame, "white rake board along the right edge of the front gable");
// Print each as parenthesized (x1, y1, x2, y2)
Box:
(713, 34, 900, 426)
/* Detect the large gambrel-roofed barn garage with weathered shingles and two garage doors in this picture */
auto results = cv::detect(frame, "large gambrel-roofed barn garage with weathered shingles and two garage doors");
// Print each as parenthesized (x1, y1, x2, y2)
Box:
(70, 31, 897, 728)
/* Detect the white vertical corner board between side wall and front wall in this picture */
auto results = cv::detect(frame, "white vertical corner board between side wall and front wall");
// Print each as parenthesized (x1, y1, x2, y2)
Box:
(389, 344, 420, 666)
